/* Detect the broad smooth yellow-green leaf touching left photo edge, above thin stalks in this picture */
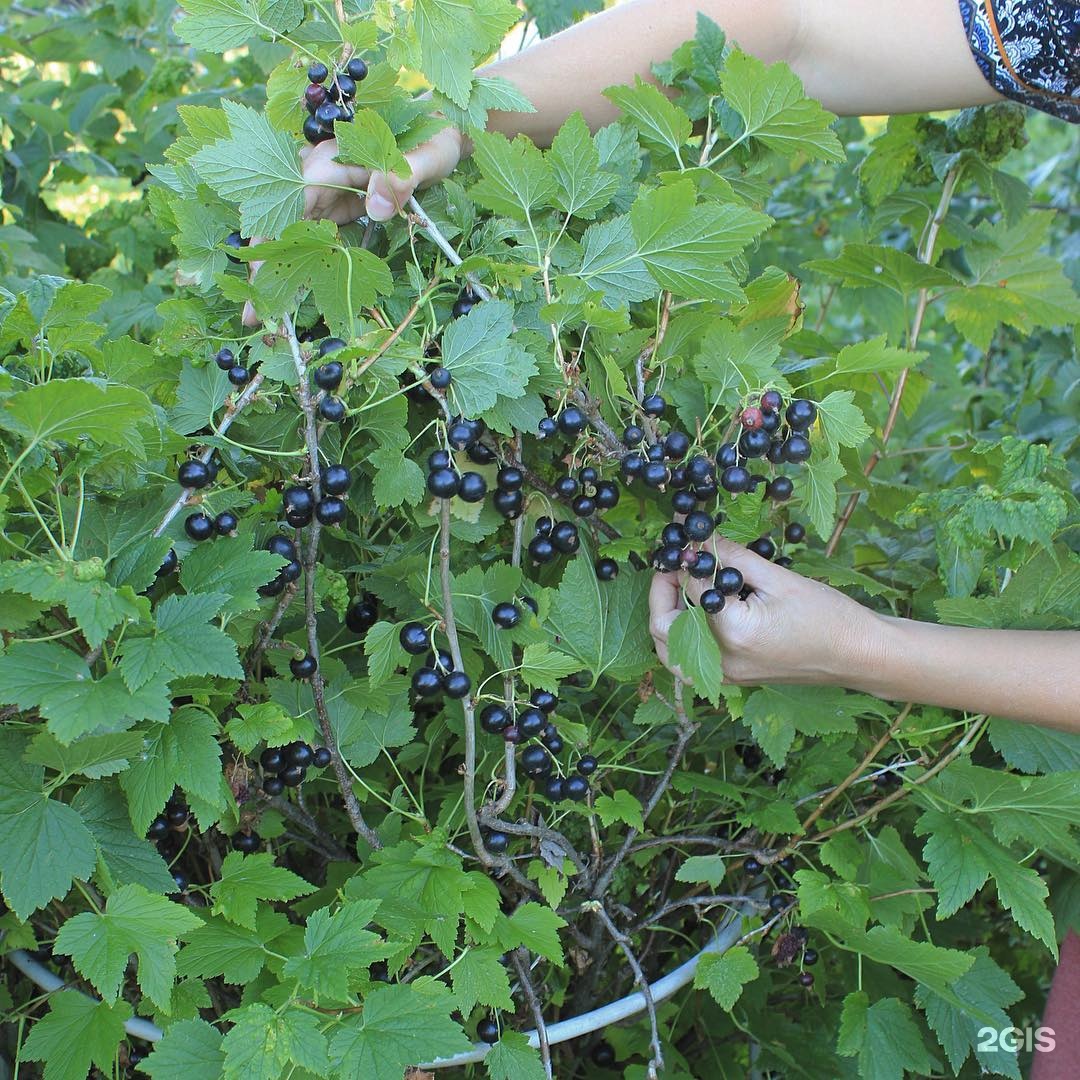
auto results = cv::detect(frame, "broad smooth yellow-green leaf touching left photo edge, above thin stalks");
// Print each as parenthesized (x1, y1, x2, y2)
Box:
(0, 379, 153, 454)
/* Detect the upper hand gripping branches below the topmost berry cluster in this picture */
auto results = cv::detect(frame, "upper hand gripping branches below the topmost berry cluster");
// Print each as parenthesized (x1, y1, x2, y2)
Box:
(244, 126, 464, 326)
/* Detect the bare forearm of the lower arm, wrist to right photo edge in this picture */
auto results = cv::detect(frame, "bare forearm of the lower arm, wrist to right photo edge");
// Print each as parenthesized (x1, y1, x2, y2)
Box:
(842, 617, 1080, 732)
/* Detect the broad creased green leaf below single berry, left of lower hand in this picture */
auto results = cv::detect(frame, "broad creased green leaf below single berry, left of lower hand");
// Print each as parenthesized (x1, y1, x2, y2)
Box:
(545, 553, 656, 684)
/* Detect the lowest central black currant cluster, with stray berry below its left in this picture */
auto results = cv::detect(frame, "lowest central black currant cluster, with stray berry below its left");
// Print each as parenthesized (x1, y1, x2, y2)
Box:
(480, 690, 597, 829)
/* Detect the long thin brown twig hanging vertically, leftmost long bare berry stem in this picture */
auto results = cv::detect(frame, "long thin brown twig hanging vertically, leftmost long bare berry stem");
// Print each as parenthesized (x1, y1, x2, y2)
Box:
(283, 314, 382, 849)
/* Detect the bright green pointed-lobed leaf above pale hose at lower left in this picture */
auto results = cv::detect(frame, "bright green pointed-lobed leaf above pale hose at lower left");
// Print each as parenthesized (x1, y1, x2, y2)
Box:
(53, 885, 201, 1012)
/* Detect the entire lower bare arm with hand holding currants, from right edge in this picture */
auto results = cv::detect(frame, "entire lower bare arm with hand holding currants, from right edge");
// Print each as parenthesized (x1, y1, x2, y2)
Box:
(649, 540, 1080, 732)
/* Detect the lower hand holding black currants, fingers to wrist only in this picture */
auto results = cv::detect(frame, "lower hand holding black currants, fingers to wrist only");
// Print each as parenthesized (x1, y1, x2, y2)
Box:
(649, 537, 882, 686)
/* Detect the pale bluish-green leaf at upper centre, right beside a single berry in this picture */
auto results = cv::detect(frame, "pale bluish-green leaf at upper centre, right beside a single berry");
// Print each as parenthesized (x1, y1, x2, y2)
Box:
(442, 300, 537, 416)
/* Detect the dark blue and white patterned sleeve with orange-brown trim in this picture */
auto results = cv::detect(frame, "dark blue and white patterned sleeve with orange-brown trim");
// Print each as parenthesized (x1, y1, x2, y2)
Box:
(960, 0, 1080, 123)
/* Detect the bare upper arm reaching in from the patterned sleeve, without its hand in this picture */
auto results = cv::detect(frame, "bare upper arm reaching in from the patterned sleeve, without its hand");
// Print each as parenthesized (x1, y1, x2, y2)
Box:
(484, 0, 999, 146)
